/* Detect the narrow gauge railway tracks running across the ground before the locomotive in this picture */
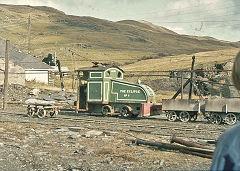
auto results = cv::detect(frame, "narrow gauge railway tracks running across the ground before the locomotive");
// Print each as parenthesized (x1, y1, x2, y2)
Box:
(0, 112, 226, 140)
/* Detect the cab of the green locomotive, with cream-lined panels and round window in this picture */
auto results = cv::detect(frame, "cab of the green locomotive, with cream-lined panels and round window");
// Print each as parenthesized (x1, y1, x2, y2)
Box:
(76, 65, 123, 111)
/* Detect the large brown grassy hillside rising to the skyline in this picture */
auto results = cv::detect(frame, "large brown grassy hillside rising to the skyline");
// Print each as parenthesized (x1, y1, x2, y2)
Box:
(0, 5, 239, 70)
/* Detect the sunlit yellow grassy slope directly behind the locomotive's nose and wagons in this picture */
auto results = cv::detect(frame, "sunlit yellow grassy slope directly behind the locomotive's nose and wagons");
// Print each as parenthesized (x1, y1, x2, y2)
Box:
(122, 48, 240, 87)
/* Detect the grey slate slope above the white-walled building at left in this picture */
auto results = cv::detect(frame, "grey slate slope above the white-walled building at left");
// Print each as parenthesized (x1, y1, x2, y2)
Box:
(0, 37, 51, 69)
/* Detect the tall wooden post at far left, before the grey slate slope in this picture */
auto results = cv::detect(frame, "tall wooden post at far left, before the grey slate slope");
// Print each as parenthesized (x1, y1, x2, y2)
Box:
(3, 40, 10, 110)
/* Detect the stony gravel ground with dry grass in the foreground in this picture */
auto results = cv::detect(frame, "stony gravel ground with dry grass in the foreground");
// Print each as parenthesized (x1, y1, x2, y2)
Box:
(0, 108, 227, 171)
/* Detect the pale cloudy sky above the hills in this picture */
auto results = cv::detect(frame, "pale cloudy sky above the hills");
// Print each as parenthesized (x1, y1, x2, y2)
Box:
(0, 0, 240, 41)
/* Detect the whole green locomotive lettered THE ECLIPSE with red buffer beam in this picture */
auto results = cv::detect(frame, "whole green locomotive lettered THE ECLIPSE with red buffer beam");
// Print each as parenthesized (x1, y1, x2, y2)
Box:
(76, 64, 161, 117)
